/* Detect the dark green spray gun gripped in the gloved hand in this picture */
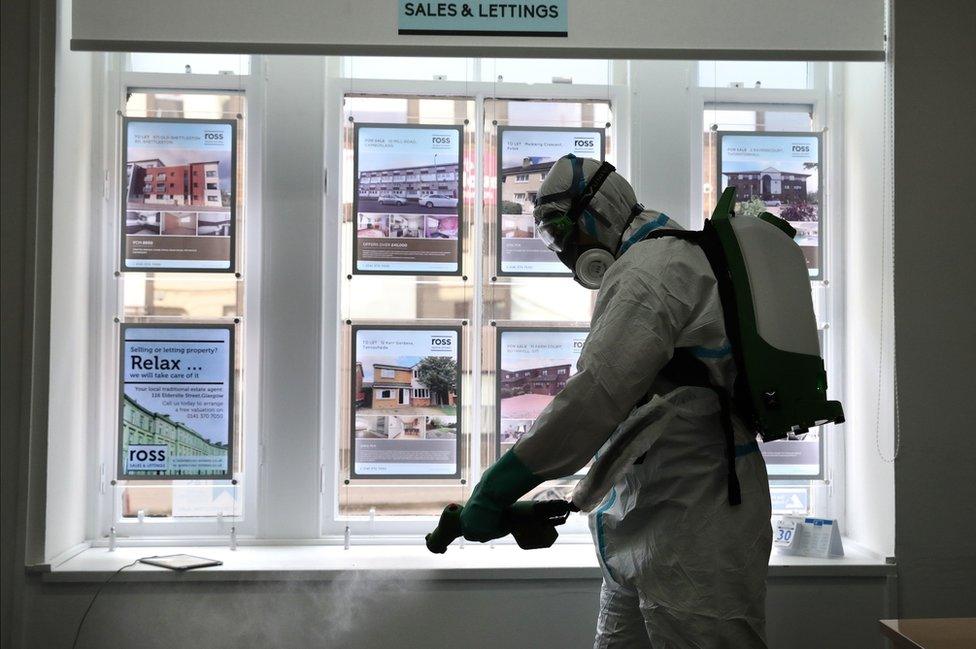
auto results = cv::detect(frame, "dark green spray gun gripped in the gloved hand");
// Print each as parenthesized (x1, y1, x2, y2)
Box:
(426, 500, 579, 554)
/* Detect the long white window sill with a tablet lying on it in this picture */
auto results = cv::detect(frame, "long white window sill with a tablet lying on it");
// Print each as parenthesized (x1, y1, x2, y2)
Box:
(36, 542, 895, 582)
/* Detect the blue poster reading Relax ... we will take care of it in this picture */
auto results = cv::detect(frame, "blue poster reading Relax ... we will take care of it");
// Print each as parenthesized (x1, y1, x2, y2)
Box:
(119, 324, 234, 479)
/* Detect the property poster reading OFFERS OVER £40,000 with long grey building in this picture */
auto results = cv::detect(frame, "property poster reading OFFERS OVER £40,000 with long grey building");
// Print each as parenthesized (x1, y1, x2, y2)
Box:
(353, 124, 464, 275)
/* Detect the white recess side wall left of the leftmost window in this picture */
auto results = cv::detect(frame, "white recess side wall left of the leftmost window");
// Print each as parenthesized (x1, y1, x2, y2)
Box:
(45, 0, 101, 559)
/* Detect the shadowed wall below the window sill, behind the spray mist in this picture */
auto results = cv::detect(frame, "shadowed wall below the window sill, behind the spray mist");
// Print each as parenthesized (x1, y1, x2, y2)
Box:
(24, 575, 886, 649)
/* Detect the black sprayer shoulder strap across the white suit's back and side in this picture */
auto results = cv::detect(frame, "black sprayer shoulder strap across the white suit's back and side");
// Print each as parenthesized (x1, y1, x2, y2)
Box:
(645, 227, 745, 506)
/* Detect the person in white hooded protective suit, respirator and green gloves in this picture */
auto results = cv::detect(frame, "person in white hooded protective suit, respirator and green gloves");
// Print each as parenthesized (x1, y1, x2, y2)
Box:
(461, 156, 772, 649)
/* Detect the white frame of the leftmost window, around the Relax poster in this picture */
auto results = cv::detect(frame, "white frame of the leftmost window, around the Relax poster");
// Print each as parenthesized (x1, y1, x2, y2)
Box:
(89, 53, 264, 544)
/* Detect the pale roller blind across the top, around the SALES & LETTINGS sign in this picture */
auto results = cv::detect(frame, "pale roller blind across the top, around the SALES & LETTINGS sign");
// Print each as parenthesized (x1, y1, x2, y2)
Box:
(72, 0, 884, 60)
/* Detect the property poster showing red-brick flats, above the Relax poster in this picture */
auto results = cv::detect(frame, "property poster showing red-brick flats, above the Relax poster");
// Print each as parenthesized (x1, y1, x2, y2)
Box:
(122, 118, 237, 272)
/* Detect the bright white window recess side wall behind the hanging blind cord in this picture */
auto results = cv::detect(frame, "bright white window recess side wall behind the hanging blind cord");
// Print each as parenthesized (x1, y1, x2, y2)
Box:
(841, 63, 895, 556)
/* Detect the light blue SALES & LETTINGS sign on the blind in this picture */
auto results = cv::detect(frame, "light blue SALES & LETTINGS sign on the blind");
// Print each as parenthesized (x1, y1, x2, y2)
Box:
(398, 0, 569, 37)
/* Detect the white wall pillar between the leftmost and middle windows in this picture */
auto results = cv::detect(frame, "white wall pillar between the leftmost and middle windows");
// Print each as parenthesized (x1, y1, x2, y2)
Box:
(260, 56, 332, 539)
